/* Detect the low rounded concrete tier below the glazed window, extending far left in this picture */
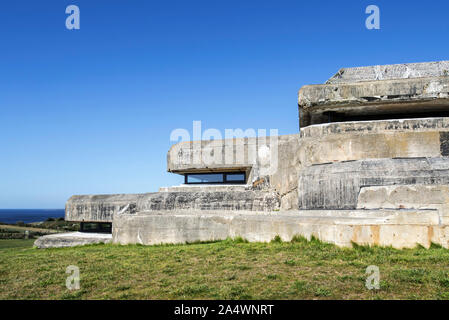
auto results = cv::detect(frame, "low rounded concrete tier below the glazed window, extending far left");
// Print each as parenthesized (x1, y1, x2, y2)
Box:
(66, 190, 280, 222)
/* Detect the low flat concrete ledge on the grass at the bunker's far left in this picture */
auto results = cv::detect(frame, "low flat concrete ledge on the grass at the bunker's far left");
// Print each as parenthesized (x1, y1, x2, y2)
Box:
(34, 232, 112, 249)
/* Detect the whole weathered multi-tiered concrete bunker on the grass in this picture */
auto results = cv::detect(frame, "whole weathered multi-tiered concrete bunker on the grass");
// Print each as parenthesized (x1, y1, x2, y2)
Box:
(36, 61, 449, 248)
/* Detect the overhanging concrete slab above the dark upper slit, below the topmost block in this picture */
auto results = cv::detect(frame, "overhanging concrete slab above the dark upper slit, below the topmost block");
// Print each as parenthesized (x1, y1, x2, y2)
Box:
(298, 77, 449, 128)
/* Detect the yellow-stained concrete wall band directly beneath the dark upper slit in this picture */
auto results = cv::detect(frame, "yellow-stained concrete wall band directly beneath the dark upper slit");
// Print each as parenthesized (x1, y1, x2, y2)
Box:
(298, 118, 449, 166)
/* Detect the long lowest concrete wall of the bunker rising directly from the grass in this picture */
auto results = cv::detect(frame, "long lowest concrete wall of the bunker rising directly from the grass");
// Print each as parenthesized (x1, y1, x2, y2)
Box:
(113, 210, 449, 248)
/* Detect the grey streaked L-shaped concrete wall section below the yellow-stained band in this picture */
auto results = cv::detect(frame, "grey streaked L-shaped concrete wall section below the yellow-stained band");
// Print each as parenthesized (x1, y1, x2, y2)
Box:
(298, 157, 449, 210)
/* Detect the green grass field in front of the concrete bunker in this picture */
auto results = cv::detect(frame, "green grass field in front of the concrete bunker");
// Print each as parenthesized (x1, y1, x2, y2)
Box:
(0, 238, 449, 299)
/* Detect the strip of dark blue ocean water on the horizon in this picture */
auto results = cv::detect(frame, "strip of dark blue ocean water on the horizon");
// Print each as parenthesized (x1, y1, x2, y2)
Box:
(0, 209, 64, 223)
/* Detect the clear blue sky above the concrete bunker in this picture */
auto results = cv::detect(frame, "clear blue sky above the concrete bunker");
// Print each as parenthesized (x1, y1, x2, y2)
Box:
(0, 0, 449, 208)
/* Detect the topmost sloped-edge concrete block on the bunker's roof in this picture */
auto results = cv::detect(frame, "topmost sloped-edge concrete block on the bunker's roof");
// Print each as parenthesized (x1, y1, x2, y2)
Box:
(326, 61, 449, 84)
